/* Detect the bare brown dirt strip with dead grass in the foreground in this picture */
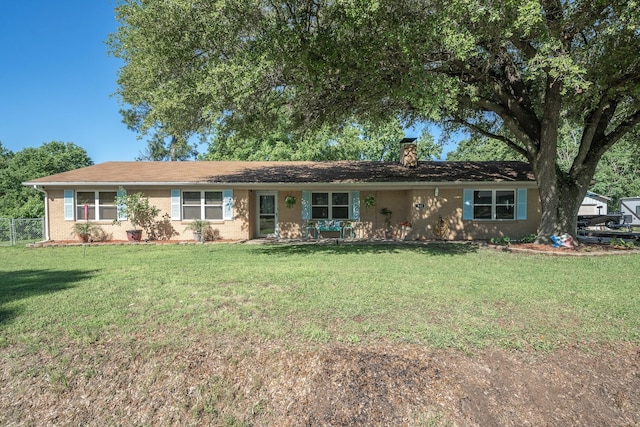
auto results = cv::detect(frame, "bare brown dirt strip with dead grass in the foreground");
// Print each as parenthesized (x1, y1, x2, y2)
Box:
(0, 337, 640, 426)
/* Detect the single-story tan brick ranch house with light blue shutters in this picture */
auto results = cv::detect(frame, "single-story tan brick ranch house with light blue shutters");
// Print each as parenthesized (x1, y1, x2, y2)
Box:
(24, 145, 540, 240)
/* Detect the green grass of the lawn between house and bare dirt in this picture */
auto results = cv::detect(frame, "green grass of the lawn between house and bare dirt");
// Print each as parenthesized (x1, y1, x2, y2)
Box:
(0, 244, 640, 352)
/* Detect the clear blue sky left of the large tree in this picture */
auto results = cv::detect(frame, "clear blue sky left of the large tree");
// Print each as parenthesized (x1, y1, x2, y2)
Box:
(0, 0, 145, 163)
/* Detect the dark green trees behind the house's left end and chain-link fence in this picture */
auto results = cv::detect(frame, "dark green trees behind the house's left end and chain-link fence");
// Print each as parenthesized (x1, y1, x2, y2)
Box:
(0, 141, 93, 218)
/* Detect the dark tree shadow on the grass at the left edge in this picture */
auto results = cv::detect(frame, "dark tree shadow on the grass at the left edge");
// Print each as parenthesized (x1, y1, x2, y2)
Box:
(0, 270, 95, 325)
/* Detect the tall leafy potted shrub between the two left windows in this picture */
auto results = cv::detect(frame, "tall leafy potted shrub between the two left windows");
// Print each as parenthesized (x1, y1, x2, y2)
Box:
(113, 189, 160, 241)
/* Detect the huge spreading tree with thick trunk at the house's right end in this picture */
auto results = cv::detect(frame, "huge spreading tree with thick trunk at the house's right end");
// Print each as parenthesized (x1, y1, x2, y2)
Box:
(109, 0, 640, 239)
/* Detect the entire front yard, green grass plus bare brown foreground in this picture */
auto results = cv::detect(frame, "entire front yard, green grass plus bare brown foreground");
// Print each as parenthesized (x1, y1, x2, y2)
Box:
(0, 243, 640, 426)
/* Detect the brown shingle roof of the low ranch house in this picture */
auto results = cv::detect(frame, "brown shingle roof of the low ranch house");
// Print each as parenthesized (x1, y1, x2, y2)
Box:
(25, 161, 535, 185)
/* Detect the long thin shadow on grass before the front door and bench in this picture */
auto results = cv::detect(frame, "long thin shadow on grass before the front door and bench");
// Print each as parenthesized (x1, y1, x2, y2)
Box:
(255, 240, 479, 256)
